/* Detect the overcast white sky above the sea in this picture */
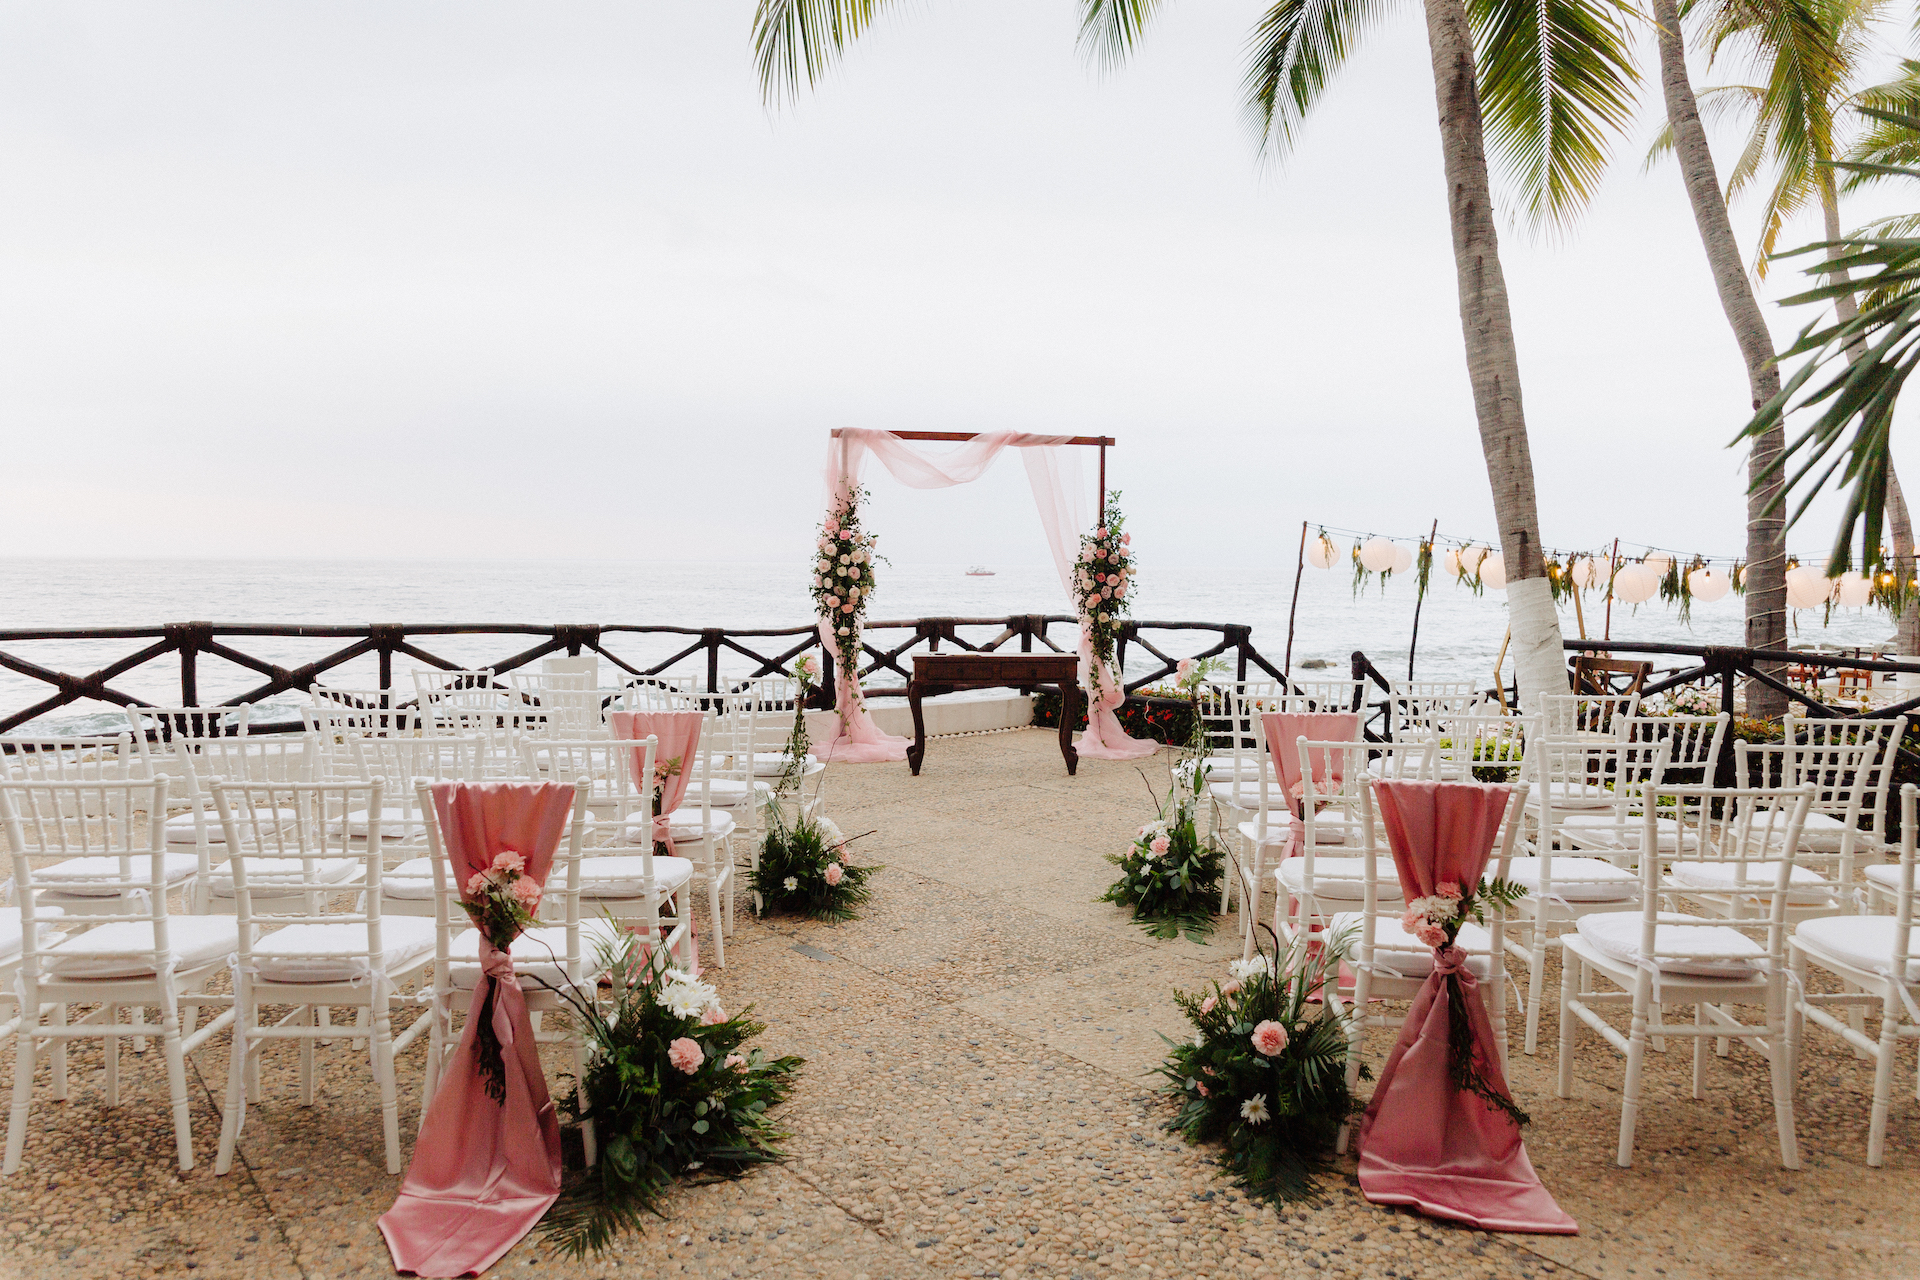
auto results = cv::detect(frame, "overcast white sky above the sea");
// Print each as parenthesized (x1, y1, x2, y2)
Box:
(0, 0, 1903, 564)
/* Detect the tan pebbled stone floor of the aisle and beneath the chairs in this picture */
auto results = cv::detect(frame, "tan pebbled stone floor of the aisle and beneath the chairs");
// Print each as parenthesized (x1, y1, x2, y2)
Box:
(0, 731, 1920, 1280)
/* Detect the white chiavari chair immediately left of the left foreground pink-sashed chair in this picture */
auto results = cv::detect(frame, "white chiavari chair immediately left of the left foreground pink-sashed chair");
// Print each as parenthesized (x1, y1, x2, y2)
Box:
(213, 781, 434, 1174)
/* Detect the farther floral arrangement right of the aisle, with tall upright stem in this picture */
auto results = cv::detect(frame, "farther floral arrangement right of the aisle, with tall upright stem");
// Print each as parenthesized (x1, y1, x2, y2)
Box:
(1098, 658, 1227, 942)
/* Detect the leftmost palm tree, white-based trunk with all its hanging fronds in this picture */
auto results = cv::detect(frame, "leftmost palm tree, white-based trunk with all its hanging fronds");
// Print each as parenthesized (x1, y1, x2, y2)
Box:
(755, 0, 1636, 706)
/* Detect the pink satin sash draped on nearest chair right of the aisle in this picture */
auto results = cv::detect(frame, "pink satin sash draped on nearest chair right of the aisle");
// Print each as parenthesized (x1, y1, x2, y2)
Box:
(1359, 781, 1580, 1236)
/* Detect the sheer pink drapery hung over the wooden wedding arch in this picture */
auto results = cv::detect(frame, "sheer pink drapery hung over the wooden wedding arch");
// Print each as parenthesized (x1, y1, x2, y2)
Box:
(816, 428, 1160, 764)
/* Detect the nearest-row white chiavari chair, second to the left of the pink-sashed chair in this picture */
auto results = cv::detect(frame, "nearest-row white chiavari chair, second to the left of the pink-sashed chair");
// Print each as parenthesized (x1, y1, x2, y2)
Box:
(0, 777, 238, 1174)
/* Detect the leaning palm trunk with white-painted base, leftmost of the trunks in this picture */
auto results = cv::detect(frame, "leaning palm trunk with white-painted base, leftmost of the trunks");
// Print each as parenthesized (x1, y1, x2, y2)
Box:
(1425, 0, 1567, 710)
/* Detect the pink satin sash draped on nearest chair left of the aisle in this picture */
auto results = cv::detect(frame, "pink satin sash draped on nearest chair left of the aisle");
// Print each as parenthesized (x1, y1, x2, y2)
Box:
(380, 783, 574, 1276)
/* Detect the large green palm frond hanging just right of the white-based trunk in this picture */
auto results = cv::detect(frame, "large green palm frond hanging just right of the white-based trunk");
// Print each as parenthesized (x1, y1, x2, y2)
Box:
(1467, 0, 1640, 226)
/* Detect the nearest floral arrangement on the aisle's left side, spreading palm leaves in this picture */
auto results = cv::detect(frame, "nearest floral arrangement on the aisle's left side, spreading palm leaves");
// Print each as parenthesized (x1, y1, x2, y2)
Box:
(545, 931, 804, 1257)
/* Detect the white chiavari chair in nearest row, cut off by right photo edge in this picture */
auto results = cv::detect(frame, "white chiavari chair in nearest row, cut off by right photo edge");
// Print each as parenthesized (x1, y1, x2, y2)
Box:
(1788, 783, 1920, 1169)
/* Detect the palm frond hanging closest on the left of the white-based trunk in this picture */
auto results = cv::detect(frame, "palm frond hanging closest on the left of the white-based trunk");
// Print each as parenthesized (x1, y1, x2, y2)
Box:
(1246, 0, 1396, 155)
